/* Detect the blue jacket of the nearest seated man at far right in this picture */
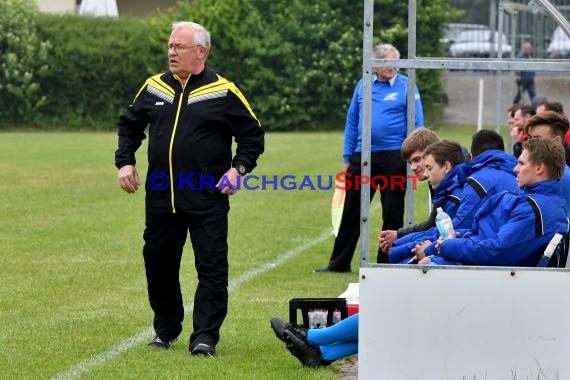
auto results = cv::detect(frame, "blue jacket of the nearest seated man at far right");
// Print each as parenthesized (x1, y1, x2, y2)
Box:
(432, 180, 568, 266)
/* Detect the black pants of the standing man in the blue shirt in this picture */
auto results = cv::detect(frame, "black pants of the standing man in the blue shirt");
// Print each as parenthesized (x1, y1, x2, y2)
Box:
(329, 150, 406, 271)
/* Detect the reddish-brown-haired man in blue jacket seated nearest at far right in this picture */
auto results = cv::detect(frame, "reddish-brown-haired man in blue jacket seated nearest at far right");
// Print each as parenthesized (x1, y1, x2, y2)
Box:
(420, 137, 568, 266)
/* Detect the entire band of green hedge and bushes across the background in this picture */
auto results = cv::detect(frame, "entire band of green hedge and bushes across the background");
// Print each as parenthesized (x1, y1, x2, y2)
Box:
(0, 0, 455, 131)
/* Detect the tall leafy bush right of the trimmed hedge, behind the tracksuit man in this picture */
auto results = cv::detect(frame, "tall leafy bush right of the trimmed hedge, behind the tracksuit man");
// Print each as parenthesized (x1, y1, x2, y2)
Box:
(152, 0, 456, 130)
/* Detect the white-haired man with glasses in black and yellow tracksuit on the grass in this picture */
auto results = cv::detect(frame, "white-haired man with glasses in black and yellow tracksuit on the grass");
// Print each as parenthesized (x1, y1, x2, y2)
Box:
(115, 22, 264, 356)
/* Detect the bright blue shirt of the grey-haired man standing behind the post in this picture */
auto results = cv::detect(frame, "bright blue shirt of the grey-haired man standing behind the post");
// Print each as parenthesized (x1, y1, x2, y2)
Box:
(343, 74, 424, 163)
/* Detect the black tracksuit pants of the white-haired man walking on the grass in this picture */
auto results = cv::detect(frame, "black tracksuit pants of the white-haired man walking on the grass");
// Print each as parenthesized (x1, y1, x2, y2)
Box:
(143, 211, 228, 349)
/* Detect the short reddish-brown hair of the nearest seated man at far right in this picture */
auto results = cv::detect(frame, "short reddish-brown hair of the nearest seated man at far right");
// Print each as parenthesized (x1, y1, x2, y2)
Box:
(524, 137, 566, 180)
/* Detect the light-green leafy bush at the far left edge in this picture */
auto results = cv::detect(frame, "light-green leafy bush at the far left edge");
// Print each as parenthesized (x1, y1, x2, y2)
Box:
(0, 0, 49, 125)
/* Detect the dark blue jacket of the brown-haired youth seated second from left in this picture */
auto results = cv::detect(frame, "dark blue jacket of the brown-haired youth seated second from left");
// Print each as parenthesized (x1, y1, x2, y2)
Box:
(389, 164, 464, 262)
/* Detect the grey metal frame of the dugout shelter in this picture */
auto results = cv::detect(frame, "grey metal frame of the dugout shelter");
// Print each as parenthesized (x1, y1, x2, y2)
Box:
(360, 0, 570, 267)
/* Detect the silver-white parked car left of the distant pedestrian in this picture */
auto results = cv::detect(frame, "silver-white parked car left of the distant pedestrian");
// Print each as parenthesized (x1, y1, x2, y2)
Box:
(449, 29, 512, 58)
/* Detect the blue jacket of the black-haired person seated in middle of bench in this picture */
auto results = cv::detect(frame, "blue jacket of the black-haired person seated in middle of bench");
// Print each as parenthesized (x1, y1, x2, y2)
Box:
(390, 149, 519, 262)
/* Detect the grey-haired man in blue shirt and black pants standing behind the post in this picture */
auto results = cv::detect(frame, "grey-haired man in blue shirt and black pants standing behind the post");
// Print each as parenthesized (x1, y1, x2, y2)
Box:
(315, 44, 424, 272)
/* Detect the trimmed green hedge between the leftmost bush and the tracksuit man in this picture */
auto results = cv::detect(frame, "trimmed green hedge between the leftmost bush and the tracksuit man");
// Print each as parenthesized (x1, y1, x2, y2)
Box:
(36, 15, 153, 129)
